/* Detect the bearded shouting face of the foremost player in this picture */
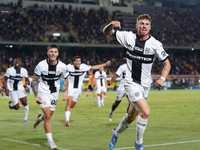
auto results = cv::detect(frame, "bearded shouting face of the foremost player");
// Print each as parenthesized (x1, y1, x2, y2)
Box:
(136, 19, 151, 36)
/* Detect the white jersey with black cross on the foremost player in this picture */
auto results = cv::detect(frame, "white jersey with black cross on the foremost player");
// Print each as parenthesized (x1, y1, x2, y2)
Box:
(115, 31, 168, 87)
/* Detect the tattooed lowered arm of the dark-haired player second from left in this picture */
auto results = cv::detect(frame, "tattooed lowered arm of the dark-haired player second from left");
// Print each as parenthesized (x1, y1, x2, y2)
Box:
(32, 74, 42, 104)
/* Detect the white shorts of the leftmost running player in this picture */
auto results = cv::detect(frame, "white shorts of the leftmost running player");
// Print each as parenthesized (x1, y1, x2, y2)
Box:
(9, 89, 27, 105)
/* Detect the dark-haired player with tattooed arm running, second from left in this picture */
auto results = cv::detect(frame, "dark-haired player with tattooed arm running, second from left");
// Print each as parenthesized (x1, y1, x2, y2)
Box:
(32, 44, 66, 149)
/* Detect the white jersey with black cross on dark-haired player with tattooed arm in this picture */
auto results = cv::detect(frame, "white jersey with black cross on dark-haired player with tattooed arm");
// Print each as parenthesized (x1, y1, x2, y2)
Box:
(35, 59, 67, 93)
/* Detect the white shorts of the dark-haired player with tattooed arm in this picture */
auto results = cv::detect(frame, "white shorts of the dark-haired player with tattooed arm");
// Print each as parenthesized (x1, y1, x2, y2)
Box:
(38, 92, 59, 111)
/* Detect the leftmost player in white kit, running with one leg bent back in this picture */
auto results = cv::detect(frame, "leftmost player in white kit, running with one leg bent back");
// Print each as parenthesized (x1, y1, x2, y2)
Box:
(3, 58, 30, 124)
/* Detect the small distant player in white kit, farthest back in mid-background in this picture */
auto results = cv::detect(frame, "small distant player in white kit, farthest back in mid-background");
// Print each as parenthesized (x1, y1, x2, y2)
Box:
(94, 67, 108, 107)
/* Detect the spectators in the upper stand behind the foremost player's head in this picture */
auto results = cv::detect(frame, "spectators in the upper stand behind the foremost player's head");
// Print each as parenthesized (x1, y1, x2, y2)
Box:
(0, 4, 200, 46)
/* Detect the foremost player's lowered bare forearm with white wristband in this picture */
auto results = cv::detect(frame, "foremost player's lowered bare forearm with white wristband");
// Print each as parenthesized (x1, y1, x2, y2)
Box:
(155, 59, 171, 87)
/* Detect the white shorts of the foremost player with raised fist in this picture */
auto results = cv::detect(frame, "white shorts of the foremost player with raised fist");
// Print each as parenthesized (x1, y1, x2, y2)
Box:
(124, 81, 150, 104)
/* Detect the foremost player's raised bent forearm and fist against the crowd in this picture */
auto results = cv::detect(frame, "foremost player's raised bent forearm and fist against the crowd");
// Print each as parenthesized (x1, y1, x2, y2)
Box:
(103, 21, 121, 36)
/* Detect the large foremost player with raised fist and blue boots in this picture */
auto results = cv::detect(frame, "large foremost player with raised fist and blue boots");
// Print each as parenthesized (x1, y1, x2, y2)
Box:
(103, 14, 171, 150)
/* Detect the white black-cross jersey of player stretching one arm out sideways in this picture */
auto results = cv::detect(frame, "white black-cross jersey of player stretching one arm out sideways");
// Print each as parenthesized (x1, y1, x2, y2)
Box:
(67, 63, 92, 89)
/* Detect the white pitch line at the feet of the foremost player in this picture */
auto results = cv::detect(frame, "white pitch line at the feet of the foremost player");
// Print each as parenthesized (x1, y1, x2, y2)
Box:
(114, 140, 200, 150)
